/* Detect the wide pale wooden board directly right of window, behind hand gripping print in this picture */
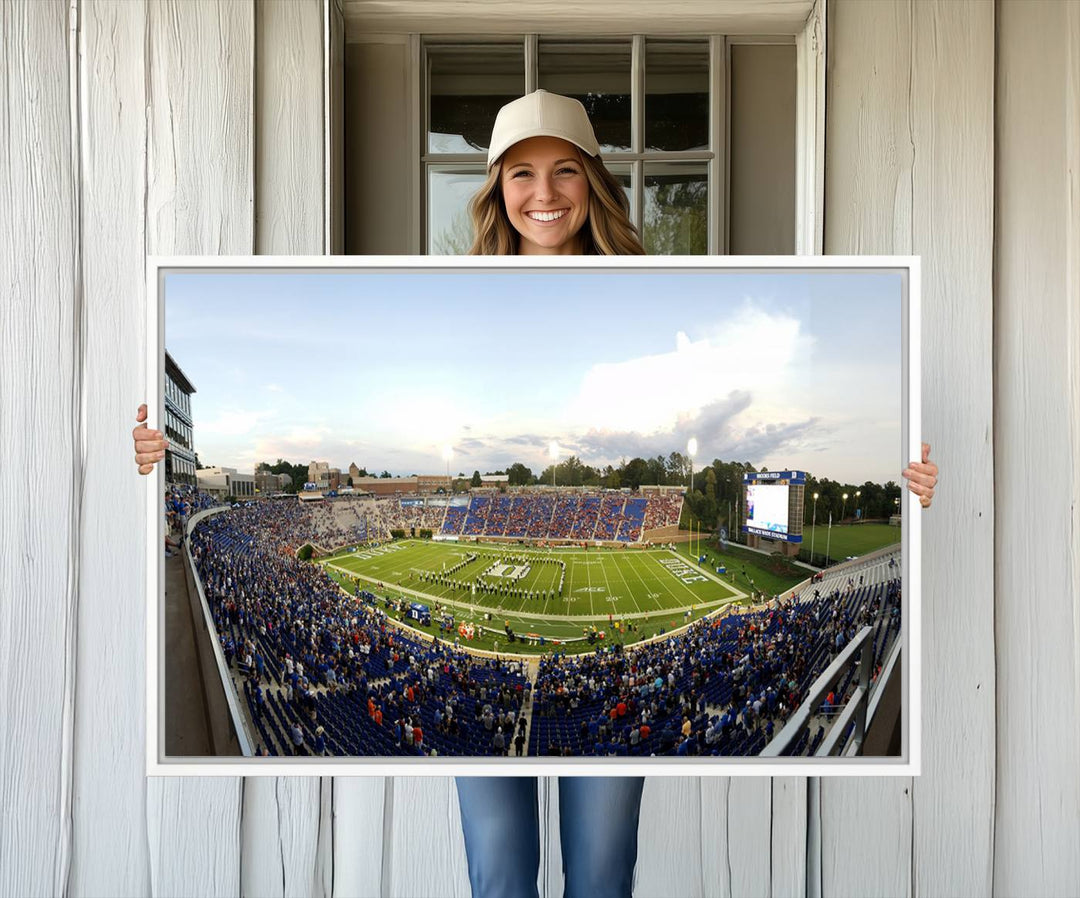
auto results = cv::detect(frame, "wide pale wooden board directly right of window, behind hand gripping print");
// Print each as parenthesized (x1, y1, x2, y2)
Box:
(821, 2, 995, 896)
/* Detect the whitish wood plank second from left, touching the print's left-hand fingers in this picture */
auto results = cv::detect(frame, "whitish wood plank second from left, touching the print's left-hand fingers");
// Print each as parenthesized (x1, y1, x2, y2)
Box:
(68, 0, 150, 898)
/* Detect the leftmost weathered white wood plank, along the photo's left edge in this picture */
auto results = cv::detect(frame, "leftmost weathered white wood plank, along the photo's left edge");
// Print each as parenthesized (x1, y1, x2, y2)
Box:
(0, 2, 83, 896)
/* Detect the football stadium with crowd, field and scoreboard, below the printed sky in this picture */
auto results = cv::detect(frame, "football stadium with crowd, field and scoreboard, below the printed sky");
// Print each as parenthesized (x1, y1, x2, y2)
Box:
(174, 469, 902, 759)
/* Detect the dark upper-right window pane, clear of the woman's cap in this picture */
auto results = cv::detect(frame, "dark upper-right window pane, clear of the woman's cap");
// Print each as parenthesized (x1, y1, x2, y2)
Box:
(645, 41, 710, 151)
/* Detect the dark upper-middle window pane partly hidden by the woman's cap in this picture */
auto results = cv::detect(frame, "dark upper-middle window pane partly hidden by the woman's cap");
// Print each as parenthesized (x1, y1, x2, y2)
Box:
(538, 40, 631, 152)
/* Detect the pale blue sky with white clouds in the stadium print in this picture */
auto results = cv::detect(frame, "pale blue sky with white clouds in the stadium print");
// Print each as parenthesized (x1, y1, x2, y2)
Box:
(165, 270, 903, 483)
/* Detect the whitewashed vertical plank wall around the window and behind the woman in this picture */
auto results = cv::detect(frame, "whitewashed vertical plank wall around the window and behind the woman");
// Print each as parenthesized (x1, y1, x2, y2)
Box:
(0, 0, 1080, 898)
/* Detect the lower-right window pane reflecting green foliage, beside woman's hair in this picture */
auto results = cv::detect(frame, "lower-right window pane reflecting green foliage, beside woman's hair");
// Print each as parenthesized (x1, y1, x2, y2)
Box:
(644, 162, 708, 256)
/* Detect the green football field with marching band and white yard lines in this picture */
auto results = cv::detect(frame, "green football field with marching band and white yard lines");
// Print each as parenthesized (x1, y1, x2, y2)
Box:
(319, 540, 746, 652)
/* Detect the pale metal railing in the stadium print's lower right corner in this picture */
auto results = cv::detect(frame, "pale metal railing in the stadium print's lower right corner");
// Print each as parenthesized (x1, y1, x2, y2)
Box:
(760, 627, 883, 758)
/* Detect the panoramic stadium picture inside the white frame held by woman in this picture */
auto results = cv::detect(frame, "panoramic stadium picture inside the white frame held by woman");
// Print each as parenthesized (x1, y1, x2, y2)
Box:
(152, 261, 906, 765)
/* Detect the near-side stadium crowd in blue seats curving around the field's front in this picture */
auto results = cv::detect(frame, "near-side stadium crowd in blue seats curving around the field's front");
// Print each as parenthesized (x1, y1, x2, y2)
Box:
(191, 501, 900, 755)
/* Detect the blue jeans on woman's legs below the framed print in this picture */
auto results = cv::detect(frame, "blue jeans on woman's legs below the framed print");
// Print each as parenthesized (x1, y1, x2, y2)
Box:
(457, 776, 645, 898)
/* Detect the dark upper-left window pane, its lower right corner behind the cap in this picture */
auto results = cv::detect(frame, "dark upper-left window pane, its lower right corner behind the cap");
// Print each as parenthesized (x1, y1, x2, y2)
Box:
(428, 43, 525, 152)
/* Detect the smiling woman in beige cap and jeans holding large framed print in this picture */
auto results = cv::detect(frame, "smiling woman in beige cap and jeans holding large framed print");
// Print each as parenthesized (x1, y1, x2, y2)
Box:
(132, 91, 937, 898)
